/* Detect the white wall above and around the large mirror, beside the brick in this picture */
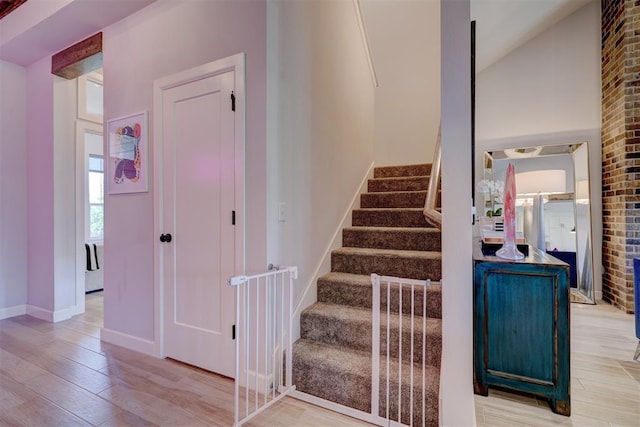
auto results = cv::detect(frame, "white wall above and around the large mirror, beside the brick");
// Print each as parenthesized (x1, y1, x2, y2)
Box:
(476, 0, 602, 295)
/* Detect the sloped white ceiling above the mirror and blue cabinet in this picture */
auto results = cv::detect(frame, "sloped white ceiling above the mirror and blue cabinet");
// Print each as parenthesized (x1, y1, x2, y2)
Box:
(471, 0, 597, 72)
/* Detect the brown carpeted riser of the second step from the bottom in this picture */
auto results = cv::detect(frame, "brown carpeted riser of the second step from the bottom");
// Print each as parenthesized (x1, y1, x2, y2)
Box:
(300, 312, 442, 366)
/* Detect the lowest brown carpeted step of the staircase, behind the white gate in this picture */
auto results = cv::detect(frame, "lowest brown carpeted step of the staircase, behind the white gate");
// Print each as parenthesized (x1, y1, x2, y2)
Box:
(293, 339, 440, 426)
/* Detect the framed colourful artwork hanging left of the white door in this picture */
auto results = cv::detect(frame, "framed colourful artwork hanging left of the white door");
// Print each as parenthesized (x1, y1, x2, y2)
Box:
(106, 111, 149, 194)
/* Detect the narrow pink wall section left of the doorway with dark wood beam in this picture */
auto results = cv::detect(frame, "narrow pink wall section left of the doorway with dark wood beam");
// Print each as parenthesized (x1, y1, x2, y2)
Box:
(27, 57, 54, 311)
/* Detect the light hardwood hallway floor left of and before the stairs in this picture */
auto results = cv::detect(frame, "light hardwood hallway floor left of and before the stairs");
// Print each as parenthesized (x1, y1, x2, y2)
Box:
(0, 293, 368, 427)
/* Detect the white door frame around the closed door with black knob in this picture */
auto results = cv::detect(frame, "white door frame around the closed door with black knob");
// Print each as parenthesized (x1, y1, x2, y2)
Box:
(153, 53, 246, 357)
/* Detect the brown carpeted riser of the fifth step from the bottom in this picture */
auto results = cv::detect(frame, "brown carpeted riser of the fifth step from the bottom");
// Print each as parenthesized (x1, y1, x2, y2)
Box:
(342, 227, 442, 251)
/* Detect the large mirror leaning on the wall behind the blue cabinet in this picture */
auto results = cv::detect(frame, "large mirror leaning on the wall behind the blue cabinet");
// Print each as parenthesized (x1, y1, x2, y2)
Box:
(476, 142, 595, 304)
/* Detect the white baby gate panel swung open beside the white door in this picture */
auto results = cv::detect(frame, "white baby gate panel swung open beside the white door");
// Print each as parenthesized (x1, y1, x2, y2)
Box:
(229, 267, 298, 426)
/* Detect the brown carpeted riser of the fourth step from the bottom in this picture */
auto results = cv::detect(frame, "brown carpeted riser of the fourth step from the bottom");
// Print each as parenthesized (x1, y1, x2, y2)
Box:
(331, 252, 442, 280)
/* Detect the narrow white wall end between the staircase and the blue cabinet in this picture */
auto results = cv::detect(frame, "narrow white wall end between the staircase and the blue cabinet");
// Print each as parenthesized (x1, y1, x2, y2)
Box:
(440, 0, 475, 426)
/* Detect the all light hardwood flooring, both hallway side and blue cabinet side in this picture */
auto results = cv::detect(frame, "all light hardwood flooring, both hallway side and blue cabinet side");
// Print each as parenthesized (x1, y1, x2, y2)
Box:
(0, 294, 640, 427)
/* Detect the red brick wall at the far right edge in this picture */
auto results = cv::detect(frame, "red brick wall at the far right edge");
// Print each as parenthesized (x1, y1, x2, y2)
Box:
(602, 0, 640, 313)
